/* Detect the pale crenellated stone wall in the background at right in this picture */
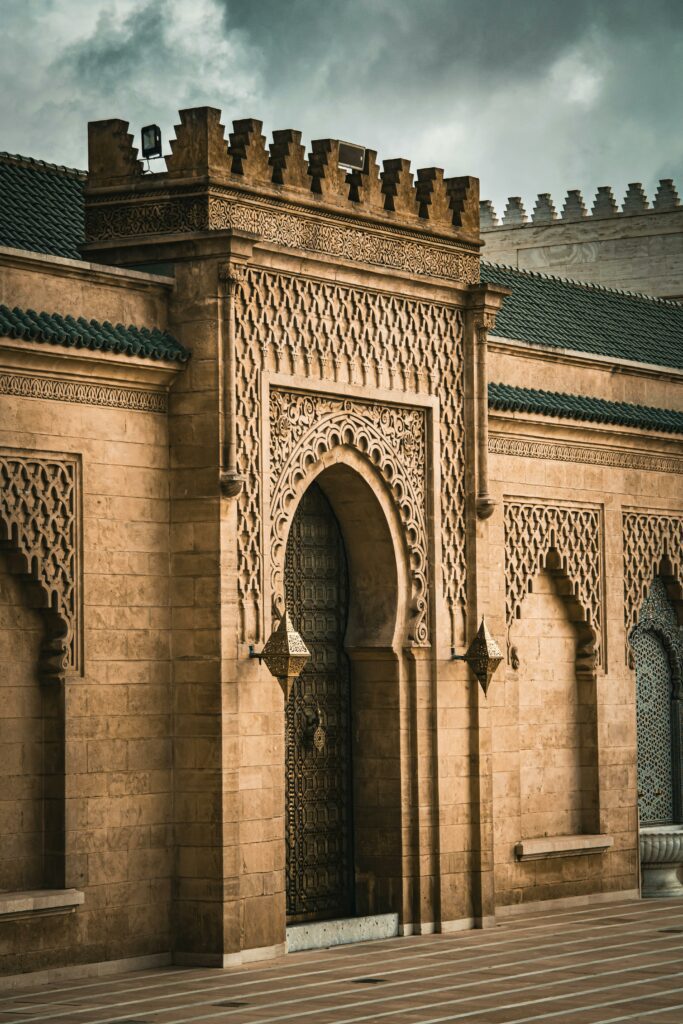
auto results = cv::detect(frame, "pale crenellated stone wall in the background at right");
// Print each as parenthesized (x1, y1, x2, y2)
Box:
(480, 178, 683, 299)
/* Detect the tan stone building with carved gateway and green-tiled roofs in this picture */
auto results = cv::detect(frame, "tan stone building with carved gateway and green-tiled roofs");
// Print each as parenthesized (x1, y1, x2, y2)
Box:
(0, 109, 683, 976)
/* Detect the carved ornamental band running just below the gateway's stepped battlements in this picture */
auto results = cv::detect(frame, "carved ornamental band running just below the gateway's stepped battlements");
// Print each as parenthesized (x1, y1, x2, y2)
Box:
(86, 189, 479, 285)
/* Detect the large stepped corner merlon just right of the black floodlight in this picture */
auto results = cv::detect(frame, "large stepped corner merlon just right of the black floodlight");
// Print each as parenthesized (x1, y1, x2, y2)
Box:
(166, 106, 230, 177)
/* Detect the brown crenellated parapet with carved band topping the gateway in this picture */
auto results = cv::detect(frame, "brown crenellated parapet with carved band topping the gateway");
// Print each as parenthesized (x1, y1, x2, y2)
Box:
(84, 106, 480, 283)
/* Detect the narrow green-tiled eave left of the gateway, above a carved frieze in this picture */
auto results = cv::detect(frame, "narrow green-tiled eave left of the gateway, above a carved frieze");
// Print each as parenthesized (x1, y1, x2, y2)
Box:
(0, 305, 189, 362)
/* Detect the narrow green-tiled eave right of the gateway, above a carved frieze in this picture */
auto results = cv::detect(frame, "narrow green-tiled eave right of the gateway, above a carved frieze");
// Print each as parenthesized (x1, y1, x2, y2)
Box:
(488, 384, 683, 434)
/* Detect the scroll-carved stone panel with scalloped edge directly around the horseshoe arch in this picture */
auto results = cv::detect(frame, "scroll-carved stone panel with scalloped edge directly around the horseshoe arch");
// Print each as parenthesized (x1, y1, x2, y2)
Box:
(269, 388, 429, 645)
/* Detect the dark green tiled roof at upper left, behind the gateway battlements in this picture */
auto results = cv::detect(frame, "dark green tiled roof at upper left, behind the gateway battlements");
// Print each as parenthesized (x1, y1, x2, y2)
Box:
(0, 153, 87, 259)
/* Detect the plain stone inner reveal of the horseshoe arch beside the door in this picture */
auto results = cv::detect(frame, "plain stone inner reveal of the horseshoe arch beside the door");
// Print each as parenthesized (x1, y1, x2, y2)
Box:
(276, 447, 411, 914)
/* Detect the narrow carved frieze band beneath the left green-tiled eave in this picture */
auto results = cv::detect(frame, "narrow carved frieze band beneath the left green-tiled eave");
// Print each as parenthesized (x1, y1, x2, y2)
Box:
(0, 374, 168, 413)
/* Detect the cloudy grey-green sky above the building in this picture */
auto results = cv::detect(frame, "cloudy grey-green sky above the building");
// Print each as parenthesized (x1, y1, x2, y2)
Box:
(0, 0, 683, 212)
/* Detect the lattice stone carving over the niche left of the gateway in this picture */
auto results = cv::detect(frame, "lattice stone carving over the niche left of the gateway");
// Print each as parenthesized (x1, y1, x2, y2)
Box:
(0, 449, 79, 680)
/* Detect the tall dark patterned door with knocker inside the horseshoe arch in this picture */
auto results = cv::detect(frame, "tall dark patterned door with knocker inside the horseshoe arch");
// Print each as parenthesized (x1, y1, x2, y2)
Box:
(285, 484, 353, 921)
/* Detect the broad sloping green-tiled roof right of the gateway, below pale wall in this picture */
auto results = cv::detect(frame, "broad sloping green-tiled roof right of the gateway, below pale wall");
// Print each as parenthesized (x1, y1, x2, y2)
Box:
(481, 262, 683, 369)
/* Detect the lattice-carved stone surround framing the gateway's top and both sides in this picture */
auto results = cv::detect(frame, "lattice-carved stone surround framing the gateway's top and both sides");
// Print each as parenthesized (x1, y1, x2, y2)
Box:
(234, 268, 466, 640)
